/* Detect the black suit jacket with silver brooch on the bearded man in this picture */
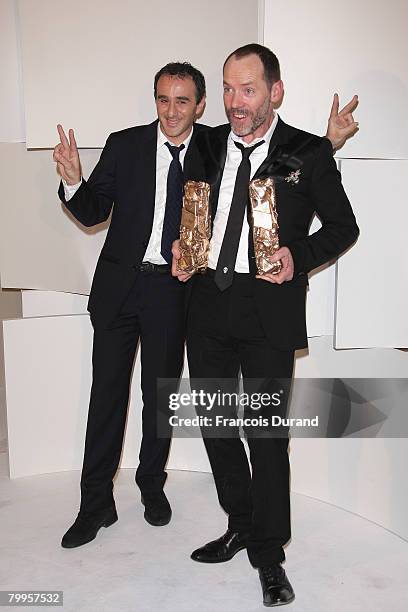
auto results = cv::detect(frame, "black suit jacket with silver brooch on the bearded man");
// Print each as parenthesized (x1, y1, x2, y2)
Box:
(185, 118, 359, 350)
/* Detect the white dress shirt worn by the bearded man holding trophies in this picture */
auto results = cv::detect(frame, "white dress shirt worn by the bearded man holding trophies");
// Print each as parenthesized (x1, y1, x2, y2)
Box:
(208, 113, 278, 272)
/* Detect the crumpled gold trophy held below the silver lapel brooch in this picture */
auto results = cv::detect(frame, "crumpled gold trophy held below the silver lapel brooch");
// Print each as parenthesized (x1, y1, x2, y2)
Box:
(249, 177, 282, 275)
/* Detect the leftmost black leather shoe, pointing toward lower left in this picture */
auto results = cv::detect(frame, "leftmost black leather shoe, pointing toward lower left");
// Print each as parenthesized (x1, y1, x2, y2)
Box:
(61, 506, 118, 548)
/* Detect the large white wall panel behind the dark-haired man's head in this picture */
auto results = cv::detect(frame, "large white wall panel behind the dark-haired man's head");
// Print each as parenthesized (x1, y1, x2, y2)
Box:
(19, 0, 258, 148)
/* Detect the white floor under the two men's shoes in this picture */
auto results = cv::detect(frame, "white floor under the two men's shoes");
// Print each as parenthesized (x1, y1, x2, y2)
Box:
(0, 441, 408, 612)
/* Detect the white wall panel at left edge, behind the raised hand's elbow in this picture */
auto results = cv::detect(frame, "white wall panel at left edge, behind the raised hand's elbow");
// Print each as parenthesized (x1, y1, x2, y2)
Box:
(0, 144, 106, 294)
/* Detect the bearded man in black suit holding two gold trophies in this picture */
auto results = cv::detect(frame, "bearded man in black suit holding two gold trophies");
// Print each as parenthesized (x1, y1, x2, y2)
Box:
(173, 44, 359, 606)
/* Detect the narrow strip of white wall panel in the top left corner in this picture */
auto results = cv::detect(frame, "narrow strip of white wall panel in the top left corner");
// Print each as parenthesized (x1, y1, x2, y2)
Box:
(0, 0, 25, 142)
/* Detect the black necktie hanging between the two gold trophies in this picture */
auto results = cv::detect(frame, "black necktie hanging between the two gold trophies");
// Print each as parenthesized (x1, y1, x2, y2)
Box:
(214, 140, 265, 291)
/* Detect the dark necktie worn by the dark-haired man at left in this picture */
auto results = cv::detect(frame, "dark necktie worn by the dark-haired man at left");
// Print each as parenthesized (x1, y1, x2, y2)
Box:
(160, 142, 184, 263)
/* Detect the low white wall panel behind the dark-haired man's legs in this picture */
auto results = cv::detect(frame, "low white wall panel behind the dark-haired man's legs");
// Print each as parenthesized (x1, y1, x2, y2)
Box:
(4, 315, 209, 478)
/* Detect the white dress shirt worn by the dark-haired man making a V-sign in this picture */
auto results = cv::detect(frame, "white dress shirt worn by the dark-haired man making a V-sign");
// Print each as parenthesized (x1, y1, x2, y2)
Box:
(62, 123, 193, 264)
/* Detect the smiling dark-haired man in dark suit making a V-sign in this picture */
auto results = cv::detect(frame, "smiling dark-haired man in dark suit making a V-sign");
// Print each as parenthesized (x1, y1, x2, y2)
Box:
(54, 63, 205, 548)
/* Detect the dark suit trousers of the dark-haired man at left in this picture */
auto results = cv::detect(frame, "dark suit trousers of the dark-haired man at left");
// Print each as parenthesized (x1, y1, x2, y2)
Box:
(81, 272, 185, 511)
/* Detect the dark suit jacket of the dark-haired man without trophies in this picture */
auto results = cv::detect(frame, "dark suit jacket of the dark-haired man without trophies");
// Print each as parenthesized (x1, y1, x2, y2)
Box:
(58, 120, 206, 327)
